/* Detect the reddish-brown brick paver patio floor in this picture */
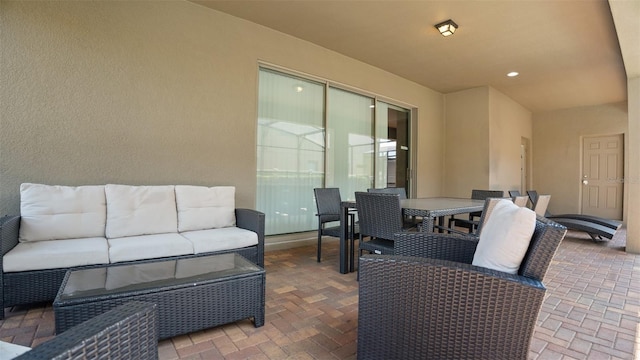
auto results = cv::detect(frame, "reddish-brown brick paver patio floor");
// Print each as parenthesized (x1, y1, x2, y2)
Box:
(0, 228, 640, 360)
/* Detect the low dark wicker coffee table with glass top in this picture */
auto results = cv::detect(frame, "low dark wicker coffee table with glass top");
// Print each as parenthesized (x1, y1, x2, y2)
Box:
(53, 253, 265, 339)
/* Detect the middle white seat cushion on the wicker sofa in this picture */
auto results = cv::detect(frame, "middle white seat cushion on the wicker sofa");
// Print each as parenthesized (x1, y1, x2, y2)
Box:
(107, 233, 193, 263)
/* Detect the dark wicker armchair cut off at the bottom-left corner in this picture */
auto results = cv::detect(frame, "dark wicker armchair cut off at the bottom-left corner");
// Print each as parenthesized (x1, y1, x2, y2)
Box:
(15, 301, 158, 360)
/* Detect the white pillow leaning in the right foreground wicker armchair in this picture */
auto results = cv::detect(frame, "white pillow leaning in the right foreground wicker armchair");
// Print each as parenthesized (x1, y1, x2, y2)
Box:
(472, 199, 536, 274)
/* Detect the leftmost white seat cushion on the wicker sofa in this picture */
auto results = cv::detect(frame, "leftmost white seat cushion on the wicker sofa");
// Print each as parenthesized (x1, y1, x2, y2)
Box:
(2, 238, 109, 272)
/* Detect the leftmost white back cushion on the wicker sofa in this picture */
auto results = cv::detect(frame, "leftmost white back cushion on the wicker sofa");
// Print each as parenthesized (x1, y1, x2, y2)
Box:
(20, 183, 107, 242)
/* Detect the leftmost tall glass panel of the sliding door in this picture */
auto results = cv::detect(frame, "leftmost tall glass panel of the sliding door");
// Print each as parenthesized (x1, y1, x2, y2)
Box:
(256, 69, 325, 235)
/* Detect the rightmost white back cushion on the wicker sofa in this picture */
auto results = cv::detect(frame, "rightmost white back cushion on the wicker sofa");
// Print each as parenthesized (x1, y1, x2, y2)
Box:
(176, 185, 236, 232)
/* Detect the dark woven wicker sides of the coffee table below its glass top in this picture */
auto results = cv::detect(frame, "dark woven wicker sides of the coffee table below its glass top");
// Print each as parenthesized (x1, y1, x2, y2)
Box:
(53, 270, 265, 339)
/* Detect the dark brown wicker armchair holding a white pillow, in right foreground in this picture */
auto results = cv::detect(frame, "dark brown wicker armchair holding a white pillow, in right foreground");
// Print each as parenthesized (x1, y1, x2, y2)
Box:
(358, 217, 566, 360)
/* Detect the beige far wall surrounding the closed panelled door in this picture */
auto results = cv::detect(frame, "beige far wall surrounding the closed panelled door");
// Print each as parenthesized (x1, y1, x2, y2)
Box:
(533, 103, 637, 218)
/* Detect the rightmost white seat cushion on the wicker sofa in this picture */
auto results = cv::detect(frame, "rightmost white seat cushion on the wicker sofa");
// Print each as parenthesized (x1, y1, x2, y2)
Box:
(180, 227, 258, 254)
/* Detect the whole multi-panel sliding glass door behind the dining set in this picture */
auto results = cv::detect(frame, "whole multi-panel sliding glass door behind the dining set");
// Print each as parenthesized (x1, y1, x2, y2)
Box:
(256, 68, 409, 235)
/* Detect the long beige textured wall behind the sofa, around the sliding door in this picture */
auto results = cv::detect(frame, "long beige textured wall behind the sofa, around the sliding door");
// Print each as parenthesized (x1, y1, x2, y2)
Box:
(0, 1, 443, 214)
